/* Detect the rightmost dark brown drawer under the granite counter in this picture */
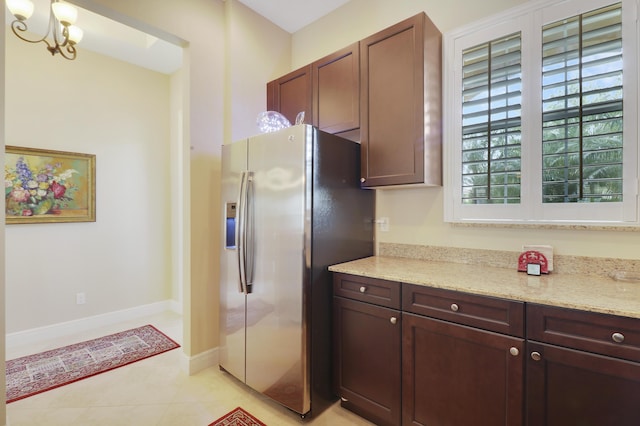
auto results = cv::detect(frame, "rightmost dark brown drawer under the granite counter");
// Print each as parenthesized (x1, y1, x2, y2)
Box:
(527, 304, 640, 362)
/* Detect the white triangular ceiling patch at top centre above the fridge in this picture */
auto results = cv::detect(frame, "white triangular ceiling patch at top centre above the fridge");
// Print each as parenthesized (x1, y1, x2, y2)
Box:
(239, 0, 350, 33)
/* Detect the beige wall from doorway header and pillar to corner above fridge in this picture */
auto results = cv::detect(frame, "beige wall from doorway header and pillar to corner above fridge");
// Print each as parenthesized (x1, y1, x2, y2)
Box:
(67, 0, 290, 356)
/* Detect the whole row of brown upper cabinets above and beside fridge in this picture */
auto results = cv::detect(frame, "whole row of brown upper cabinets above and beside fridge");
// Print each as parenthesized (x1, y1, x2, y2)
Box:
(267, 13, 442, 188)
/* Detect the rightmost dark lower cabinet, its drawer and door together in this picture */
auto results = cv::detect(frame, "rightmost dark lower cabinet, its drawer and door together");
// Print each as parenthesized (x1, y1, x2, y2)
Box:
(526, 304, 640, 426)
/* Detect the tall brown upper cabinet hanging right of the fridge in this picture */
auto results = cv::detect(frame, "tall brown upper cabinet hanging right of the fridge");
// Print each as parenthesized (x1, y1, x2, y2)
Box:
(360, 13, 442, 186)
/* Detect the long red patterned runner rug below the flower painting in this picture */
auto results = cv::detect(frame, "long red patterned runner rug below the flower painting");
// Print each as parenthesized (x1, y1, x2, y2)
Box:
(7, 325, 180, 403)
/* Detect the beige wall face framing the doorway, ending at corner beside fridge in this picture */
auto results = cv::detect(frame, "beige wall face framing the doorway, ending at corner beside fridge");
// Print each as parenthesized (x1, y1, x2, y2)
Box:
(77, 0, 224, 356)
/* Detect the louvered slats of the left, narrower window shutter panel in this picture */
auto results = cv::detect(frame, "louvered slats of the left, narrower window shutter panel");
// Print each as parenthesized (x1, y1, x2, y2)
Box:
(462, 33, 522, 204)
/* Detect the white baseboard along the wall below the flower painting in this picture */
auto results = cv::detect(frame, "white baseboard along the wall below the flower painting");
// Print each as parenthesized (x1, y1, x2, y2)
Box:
(5, 300, 182, 348)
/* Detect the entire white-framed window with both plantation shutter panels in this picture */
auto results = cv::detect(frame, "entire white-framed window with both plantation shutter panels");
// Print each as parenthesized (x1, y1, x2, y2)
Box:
(443, 0, 640, 226)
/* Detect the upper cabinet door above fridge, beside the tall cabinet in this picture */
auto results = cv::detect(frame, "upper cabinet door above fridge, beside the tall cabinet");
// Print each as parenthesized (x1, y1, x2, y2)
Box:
(311, 43, 360, 133)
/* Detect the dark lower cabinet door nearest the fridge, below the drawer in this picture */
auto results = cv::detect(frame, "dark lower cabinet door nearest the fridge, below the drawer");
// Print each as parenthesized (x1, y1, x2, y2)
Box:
(334, 297, 401, 425)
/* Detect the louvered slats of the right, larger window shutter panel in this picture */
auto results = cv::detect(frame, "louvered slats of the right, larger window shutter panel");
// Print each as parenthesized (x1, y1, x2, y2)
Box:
(542, 3, 623, 203)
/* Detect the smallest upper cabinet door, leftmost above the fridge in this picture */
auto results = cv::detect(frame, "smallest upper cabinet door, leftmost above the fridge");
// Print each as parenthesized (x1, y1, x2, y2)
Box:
(267, 65, 313, 125)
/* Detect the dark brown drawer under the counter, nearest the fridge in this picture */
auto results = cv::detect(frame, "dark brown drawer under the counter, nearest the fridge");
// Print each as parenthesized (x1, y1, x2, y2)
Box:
(333, 273, 400, 309)
